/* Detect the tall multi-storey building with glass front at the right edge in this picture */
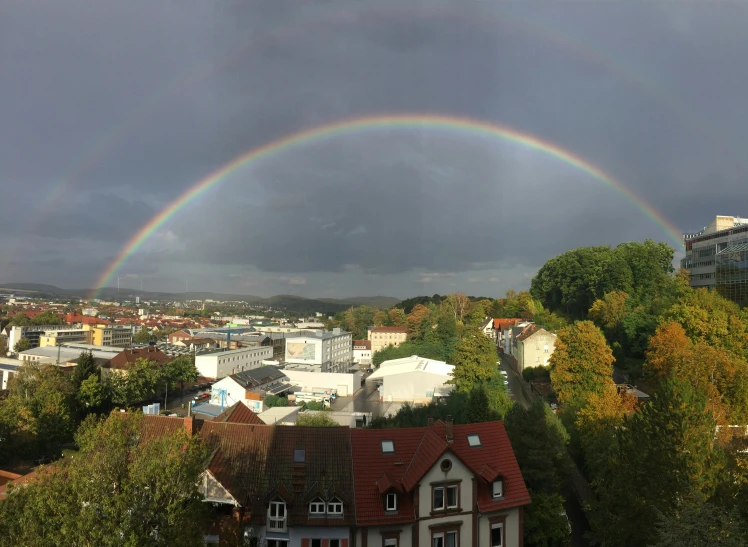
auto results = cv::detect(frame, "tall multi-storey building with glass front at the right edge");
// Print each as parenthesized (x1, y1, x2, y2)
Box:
(681, 216, 748, 303)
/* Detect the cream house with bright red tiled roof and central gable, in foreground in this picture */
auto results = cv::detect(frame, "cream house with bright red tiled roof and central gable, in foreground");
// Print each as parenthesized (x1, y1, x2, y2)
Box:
(351, 419, 530, 547)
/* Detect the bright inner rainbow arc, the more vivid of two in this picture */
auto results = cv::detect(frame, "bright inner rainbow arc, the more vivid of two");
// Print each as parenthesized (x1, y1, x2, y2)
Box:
(90, 114, 682, 298)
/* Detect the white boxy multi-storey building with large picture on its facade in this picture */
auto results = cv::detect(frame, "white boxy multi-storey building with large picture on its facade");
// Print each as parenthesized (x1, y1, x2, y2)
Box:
(286, 329, 353, 372)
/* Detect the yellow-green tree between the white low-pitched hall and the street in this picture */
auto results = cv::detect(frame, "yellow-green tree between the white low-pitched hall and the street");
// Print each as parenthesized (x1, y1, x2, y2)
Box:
(450, 329, 497, 393)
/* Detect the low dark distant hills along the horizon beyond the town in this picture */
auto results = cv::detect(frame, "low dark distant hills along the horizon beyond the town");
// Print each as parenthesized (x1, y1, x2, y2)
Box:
(0, 283, 399, 315)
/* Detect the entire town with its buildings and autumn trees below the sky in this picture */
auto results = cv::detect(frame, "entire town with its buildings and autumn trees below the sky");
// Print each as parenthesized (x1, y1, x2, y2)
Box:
(0, 217, 748, 547)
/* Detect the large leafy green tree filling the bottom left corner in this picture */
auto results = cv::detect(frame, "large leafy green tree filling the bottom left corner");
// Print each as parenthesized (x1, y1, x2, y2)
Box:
(0, 413, 210, 547)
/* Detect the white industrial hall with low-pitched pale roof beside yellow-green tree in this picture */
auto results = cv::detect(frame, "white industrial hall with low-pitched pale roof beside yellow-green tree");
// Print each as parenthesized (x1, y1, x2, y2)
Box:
(367, 355, 454, 403)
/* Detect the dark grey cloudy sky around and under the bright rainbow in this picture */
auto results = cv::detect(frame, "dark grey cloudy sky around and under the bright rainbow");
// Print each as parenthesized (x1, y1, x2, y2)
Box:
(0, 0, 748, 298)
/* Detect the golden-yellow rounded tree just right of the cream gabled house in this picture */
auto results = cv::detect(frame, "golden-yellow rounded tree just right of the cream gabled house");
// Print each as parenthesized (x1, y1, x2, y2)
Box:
(549, 321, 613, 408)
